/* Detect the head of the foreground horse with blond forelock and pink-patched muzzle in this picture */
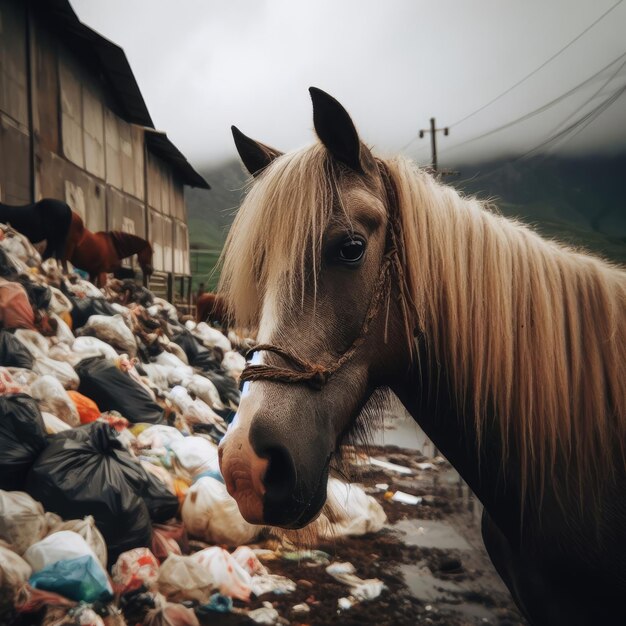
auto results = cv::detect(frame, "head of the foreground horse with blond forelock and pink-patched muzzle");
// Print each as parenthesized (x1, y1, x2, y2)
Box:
(220, 88, 410, 528)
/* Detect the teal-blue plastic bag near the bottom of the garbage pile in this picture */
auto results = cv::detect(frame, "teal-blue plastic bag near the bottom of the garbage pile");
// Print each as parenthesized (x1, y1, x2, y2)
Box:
(28, 555, 113, 603)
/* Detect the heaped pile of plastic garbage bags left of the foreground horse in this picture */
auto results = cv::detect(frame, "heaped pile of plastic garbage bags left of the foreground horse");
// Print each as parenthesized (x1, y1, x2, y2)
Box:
(0, 225, 386, 626)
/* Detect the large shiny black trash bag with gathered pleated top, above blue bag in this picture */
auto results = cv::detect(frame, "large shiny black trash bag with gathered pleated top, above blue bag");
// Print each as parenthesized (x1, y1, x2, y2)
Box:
(26, 422, 178, 563)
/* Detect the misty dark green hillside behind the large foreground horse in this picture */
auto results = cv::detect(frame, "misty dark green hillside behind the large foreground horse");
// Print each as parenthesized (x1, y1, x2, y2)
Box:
(186, 154, 626, 289)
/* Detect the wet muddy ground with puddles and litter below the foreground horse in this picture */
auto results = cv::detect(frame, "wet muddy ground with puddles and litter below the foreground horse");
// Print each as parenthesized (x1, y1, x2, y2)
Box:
(205, 414, 526, 626)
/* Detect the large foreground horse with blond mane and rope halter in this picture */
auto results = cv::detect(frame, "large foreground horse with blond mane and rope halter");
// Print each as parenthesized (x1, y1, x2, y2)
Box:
(219, 88, 626, 626)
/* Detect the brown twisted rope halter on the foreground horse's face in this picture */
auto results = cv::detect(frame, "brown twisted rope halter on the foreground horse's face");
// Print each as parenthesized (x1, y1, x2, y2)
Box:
(236, 159, 404, 391)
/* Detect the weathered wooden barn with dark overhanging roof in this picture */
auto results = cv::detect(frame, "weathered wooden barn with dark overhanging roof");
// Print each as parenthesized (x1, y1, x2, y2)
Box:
(0, 0, 209, 303)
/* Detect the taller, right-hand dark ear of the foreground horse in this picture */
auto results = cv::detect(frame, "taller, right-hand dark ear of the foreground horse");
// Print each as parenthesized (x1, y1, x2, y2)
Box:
(309, 87, 365, 174)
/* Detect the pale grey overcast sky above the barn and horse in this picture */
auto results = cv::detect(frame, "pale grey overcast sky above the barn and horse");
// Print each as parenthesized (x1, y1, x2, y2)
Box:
(71, 0, 626, 167)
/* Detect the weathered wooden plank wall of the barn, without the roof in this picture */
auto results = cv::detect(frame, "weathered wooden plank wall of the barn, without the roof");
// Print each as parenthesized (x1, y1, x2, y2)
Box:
(0, 0, 189, 274)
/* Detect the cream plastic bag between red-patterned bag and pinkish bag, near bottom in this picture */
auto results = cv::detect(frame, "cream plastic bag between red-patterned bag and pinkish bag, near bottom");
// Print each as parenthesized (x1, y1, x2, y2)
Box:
(159, 554, 213, 603)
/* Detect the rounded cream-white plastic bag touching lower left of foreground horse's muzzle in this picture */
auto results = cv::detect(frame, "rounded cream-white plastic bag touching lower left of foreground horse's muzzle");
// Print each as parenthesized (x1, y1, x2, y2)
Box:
(181, 476, 261, 546)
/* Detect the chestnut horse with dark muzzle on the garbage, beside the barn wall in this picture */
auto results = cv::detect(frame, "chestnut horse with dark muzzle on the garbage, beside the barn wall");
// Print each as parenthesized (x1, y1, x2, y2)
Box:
(62, 211, 153, 286)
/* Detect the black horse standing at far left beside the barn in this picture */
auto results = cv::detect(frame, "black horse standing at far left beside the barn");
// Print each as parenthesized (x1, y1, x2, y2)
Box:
(0, 198, 72, 261)
